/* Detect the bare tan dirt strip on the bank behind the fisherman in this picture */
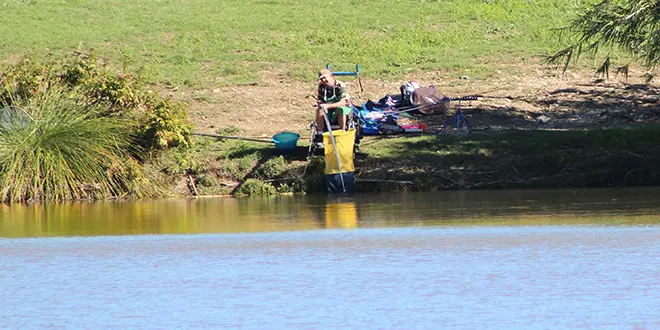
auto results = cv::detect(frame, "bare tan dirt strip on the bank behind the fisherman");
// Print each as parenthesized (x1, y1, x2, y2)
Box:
(163, 66, 660, 137)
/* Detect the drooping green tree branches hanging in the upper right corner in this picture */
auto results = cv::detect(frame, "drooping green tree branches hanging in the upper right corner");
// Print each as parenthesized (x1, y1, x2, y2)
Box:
(546, 0, 660, 80)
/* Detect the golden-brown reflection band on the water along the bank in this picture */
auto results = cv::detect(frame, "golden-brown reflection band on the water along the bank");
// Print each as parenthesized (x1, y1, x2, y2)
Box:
(0, 188, 660, 237)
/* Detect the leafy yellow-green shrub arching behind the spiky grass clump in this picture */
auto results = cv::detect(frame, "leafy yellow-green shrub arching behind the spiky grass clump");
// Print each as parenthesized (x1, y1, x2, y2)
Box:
(0, 51, 192, 149)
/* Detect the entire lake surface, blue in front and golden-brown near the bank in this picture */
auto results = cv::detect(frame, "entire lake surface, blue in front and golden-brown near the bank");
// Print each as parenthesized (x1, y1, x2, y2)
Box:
(0, 188, 660, 329)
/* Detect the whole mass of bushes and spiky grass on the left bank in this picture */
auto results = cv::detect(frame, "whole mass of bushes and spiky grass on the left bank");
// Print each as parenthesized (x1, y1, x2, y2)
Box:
(0, 51, 192, 201)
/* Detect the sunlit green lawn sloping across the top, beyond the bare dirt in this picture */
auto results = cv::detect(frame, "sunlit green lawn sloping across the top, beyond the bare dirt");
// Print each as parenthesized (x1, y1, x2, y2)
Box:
(0, 0, 593, 87)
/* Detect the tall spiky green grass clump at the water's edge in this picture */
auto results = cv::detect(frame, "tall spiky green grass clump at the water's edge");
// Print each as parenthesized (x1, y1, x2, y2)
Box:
(0, 91, 149, 202)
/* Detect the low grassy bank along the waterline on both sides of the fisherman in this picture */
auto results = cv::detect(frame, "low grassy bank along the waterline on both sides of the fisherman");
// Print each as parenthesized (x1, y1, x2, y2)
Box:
(159, 126, 660, 195)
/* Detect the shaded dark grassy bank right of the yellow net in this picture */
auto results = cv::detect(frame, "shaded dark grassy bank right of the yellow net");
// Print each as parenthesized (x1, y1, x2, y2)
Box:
(360, 126, 660, 190)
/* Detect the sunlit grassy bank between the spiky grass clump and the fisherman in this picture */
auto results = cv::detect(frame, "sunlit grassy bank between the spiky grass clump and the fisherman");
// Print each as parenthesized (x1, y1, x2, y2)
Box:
(147, 131, 324, 196)
